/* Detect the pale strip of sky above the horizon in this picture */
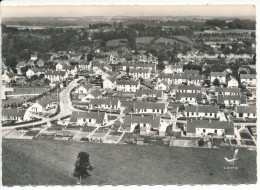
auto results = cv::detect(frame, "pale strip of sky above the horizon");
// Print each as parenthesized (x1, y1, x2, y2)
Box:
(1, 5, 256, 18)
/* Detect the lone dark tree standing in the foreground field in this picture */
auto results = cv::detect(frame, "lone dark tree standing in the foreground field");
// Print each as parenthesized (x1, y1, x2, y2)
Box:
(73, 152, 93, 183)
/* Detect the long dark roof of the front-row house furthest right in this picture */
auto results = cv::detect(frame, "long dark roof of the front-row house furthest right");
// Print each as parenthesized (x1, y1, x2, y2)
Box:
(187, 120, 234, 135)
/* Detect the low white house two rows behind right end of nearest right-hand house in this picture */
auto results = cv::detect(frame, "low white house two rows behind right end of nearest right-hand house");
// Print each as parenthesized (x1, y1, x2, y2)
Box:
(217, 95, 247, 106)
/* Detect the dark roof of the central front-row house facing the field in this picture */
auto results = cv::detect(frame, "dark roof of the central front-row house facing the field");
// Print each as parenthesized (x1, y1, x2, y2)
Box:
(123, 115, 160, 129)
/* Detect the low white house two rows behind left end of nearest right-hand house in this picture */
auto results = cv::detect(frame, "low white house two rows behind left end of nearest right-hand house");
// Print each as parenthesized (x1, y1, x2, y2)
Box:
(175, 93, 202, 104)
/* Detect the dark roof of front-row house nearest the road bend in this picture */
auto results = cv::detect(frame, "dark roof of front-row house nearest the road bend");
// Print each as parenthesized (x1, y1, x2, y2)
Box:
(70, 111, 105, 124)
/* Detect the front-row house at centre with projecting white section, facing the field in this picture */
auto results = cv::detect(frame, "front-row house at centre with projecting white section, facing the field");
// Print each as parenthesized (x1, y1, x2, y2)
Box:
(121, 115, 160, 135)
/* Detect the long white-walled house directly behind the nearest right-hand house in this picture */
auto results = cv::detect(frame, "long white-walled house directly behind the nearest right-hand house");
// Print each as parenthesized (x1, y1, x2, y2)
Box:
(184, 105, 219, 118)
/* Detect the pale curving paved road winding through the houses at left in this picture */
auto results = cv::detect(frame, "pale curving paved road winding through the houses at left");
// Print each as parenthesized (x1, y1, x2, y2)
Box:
(2, 77, 82, 130)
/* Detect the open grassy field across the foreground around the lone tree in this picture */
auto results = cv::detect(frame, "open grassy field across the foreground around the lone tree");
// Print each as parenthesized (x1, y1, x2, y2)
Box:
(2, 139, 256, 185)
